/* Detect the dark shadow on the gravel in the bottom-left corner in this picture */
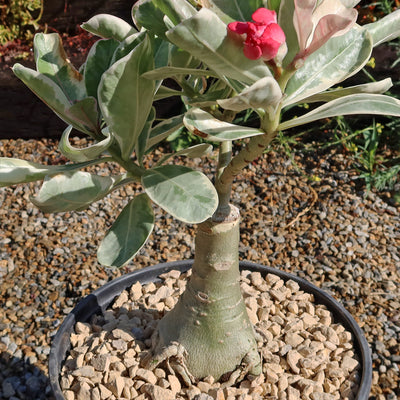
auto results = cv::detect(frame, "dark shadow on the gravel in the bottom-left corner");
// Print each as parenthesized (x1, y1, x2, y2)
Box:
(0, 352, 54, 400)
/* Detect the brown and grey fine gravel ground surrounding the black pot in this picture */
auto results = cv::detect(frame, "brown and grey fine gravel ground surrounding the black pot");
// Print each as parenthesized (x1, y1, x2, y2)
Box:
(0, 140, 400, 400)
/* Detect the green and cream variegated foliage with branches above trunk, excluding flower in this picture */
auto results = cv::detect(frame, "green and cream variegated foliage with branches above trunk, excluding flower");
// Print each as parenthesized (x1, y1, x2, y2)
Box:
(0, 0, 400, 266)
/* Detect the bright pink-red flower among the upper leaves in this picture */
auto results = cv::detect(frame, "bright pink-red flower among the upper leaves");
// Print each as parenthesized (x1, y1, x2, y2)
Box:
(228, 8, 286, 61)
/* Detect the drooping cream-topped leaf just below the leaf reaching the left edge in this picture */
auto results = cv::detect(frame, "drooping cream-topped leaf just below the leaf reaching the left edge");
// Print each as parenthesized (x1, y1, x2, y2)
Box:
(30, 171, 116, 213)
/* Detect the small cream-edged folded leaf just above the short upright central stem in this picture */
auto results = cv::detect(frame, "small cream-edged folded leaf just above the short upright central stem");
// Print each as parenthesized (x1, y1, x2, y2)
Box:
(183, 108, 264, 142)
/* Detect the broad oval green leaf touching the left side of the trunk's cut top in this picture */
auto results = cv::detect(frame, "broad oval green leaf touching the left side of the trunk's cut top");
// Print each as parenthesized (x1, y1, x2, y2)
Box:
(142, 165, 218, 223)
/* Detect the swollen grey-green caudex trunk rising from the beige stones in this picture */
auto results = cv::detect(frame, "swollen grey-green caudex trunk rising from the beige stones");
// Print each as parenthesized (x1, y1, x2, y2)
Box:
(146, 207, 261, 383)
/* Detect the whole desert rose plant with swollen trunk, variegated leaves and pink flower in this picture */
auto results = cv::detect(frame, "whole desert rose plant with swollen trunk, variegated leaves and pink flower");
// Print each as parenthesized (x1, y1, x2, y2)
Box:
(0, 0, 400, 383)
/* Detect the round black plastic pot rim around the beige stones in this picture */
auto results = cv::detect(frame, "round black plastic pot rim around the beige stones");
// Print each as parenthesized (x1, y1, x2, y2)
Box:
(49, 260, 372, 400)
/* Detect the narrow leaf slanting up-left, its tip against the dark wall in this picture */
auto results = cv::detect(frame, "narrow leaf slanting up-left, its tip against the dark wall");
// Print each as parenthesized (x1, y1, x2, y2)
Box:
(13, 64, 92, 135)
